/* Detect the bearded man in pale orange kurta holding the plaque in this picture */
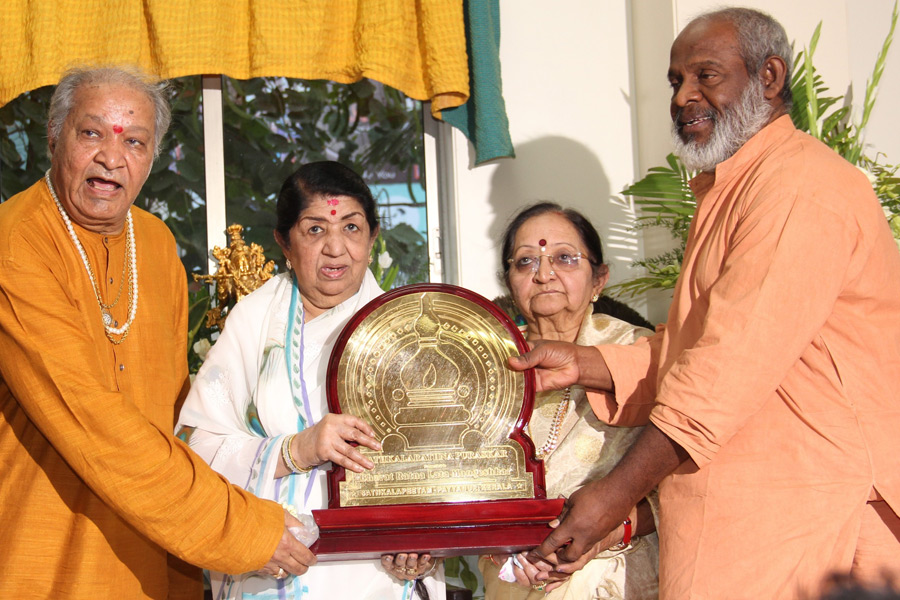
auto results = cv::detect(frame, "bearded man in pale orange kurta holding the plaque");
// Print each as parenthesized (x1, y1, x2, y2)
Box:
(511, 9, 900, 600)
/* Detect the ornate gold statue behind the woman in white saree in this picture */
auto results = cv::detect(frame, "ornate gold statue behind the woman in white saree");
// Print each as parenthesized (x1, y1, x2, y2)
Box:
(194, 223, 275, 330)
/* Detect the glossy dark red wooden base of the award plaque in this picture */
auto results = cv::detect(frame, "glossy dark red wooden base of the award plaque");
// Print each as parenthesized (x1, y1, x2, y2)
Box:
(310, 499, 564, 562)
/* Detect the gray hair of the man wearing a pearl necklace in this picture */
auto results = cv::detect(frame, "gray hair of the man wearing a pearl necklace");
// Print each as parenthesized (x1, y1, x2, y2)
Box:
(47, 66, 172, 157)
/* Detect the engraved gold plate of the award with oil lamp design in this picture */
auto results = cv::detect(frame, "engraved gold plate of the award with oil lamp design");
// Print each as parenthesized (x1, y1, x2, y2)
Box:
(336, 291, 535, 507)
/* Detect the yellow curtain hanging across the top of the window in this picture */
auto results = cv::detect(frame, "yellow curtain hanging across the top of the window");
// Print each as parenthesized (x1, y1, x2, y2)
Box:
(0, 0, 469, 116)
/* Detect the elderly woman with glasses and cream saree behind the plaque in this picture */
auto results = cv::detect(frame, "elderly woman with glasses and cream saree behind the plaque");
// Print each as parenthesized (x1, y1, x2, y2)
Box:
(479, 202, 658, 600)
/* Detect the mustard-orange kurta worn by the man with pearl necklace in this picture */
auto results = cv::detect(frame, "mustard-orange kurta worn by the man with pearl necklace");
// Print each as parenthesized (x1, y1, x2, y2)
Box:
(0, 182, 283, 598)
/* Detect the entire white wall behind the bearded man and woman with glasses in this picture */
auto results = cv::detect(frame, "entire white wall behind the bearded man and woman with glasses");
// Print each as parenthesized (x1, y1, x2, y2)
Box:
(445, 0, 900, 322)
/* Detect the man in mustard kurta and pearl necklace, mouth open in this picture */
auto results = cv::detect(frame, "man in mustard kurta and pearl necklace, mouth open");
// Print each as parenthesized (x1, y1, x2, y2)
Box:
(0, 68, 315, 600)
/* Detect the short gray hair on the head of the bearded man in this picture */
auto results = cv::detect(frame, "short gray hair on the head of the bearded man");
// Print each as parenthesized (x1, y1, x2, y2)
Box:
(692, 8, 794, 110)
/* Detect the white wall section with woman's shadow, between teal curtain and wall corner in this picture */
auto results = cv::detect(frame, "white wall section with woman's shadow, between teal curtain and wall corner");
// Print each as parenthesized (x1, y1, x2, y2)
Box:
(447, 0, 639, 298)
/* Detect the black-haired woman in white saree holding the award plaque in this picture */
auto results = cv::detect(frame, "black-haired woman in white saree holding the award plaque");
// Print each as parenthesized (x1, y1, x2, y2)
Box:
(176, 161, 445, 600)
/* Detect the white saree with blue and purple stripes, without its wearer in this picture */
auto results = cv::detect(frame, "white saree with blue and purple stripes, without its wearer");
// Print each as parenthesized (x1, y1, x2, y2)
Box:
(175, 270, 444, 600)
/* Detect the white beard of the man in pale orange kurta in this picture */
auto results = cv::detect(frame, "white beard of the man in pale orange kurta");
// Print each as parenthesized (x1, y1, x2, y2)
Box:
(672, 81, 772, 171)
